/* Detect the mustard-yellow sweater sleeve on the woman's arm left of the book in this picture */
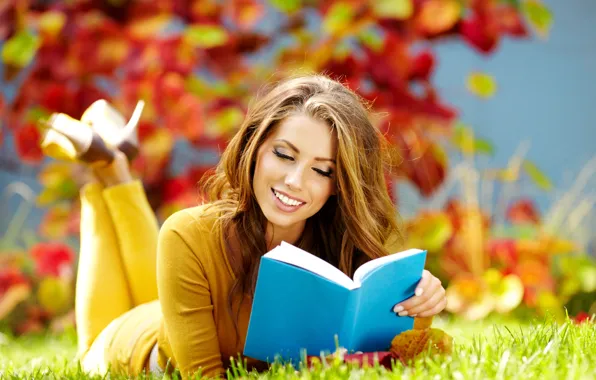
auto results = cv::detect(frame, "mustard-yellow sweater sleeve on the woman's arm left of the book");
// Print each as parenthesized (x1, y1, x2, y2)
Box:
(157, 210, 224, 378)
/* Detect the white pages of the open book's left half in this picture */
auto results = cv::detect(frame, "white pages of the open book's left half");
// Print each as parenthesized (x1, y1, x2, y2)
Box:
(264, 241, 356, 289)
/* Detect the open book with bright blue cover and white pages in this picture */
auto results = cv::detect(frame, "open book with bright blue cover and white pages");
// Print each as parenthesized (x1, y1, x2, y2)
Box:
(244, 242, 426, 362)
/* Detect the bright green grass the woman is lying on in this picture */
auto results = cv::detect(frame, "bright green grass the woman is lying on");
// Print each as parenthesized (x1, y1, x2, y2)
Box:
(0, 319, 596, 380)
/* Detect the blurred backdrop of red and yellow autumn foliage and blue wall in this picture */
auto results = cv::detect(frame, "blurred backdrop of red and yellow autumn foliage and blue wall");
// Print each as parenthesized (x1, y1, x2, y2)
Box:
(0, 0, 596, 334)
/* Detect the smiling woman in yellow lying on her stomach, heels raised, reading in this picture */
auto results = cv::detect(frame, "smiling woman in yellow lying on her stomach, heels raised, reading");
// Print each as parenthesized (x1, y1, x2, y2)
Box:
(42, 76, 446, 377)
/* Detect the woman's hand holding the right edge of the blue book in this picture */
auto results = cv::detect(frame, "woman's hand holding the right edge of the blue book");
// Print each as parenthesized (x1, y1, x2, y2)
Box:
(393, 270, 447, 317)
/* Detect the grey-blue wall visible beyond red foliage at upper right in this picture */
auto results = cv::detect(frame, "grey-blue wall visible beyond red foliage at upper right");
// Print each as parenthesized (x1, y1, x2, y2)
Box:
(400, 0, 596, 220)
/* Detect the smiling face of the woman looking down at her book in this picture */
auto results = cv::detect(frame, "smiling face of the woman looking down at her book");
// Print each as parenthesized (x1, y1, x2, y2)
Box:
(253, 114, 337, 235)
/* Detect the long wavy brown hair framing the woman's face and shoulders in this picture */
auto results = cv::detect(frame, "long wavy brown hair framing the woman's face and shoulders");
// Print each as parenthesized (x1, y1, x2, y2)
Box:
(204, 75, 403, 330)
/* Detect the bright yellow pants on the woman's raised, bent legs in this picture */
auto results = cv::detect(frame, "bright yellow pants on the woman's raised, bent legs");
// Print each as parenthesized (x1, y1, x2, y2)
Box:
(75, 181, 161, 375)
